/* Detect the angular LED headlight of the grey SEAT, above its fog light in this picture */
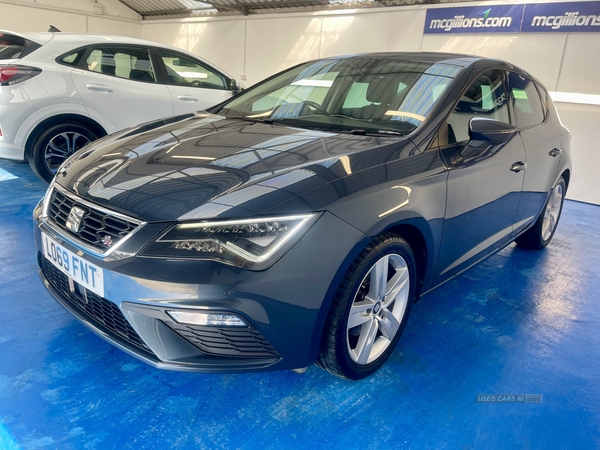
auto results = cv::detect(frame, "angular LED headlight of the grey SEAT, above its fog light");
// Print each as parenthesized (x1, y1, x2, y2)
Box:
(141, 214, 319, 270)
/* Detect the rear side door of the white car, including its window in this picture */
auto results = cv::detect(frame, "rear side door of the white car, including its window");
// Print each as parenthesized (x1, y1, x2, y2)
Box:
(71, 45, 173, 131)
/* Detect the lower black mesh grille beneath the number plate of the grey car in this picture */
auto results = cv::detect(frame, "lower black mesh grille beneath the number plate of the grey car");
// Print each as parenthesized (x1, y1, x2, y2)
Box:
(42, 258, 152, 354)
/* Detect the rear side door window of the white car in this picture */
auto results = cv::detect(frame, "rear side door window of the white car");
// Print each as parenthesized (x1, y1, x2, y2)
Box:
(85, 47, 156, 83)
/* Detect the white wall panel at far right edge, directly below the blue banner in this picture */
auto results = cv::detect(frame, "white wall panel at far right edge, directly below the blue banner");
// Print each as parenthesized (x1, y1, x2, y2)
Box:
(556, 33, 600, 94)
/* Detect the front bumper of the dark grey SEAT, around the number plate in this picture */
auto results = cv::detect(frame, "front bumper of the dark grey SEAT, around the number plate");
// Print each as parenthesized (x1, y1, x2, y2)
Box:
(35, 207, 365, 372)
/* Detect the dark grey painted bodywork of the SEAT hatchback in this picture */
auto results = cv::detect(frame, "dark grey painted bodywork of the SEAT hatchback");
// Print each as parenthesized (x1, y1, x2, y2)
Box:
(35, 54, 570, 371)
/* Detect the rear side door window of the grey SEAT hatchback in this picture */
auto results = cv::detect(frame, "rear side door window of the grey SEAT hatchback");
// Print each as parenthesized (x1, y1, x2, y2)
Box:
(508, 72, 544, 128)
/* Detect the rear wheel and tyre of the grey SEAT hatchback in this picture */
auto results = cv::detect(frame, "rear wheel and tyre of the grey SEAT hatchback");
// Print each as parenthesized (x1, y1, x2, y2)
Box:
(515, 177, 567, 250)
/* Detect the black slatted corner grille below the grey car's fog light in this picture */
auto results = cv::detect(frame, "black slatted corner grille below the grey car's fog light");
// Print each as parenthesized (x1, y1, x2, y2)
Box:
(167, 323, 279, 358)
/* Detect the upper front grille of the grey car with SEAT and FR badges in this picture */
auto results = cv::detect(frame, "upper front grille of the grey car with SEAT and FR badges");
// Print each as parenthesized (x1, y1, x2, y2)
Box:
(48, 189, 139, 253)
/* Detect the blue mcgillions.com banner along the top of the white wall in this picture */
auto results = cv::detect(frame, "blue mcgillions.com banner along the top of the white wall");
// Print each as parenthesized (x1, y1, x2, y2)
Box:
(424, 2, 600, 34)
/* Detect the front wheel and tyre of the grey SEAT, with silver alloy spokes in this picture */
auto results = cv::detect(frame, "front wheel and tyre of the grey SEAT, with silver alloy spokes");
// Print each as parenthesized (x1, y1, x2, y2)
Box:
(318, 233, 416, 380)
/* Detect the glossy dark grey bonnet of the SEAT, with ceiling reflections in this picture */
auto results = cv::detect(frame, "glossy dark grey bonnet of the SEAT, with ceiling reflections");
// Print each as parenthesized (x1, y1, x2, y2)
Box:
(55, 113, 408, 222)
